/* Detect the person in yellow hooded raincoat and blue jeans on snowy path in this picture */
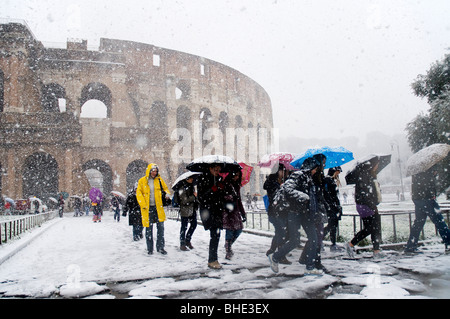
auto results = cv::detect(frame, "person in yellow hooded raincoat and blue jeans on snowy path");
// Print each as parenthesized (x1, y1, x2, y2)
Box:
(136, 163, 170, 255)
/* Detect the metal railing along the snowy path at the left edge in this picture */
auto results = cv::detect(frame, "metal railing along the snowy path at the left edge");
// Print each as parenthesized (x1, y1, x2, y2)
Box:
(0, 210, 59, 245)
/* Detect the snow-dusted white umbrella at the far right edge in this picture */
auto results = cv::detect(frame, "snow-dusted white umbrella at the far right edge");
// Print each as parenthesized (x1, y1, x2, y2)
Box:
(406, 143, 450, 176)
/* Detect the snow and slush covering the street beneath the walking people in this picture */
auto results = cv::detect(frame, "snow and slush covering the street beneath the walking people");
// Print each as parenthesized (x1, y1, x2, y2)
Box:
(0, 211, 450, 299)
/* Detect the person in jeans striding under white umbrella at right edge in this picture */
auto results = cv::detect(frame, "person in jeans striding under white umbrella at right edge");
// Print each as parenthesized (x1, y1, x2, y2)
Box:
(404, 167, 450, 253)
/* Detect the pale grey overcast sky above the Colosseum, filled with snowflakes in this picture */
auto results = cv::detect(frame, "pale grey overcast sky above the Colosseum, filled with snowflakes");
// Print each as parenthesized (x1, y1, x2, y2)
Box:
(0, 0, 450, 138)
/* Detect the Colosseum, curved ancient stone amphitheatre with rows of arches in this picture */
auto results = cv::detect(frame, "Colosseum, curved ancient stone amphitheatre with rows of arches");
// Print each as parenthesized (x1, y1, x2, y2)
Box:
(0, 22, 273, 204)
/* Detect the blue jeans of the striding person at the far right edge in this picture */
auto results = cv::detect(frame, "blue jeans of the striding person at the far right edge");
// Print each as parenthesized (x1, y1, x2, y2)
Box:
(406, 199, 450, 250)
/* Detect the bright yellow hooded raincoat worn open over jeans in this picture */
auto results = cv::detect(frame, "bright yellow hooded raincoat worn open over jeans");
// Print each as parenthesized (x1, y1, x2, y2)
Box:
(136, 163, 170, 227)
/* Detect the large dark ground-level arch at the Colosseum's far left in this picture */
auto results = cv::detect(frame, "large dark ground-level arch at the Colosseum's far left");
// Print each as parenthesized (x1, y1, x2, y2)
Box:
(22, 152, 59, 199)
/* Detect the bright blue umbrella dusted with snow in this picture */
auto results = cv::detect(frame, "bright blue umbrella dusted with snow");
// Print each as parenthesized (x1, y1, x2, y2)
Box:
(291, 146, 353, 168)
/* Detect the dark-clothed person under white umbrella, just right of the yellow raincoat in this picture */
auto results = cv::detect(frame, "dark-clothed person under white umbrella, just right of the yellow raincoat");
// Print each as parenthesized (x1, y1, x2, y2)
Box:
(175, 176, 198, 251)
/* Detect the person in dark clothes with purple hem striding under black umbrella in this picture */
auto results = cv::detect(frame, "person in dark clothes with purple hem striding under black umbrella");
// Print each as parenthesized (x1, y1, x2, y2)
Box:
(345, 157, 384, 258)
